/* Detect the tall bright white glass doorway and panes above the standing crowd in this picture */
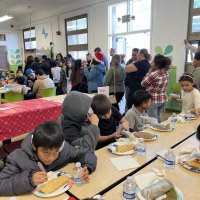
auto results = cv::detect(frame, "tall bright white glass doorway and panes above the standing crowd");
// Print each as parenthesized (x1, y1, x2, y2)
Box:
(108, 0, 151, 60)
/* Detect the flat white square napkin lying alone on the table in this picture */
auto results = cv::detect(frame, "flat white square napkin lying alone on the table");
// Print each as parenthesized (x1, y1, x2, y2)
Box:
(110, 155, 140, 171)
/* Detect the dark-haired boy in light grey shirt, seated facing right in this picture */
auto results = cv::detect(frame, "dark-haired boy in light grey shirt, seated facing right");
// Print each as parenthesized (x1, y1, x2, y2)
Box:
(125, 90, 158, 131)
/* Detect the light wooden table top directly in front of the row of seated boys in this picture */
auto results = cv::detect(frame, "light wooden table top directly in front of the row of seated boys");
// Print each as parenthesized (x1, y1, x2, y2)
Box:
(62, 119, 200, 199)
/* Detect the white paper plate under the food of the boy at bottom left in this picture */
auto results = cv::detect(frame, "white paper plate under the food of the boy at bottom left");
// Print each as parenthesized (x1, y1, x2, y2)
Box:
(32, 171, 72, 198)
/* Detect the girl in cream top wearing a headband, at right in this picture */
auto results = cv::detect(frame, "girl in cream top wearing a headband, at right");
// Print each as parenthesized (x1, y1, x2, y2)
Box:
(172, 73, 200, 113)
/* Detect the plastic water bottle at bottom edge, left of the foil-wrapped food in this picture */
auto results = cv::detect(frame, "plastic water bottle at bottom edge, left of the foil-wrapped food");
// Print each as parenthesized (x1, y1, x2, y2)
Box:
(122, 176, 136, 200)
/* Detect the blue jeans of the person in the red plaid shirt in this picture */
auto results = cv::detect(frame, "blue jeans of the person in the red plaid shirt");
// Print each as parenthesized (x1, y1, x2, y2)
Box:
(147, 102, 166, 123)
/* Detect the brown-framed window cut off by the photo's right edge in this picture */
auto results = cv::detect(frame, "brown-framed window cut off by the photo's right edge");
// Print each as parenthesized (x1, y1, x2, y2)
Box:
(186, 0, 200, 62)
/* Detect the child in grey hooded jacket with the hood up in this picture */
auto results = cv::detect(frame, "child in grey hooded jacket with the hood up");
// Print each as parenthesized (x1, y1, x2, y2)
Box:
(59, 91, 100, 150)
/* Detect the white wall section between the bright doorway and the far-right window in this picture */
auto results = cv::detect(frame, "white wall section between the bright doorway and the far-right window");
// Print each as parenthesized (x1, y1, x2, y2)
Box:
(151, 0, 189, 77)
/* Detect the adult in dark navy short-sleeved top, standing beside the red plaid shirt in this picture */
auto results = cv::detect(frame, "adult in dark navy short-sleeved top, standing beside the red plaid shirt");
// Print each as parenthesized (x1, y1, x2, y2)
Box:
(125, 49, 151, 109)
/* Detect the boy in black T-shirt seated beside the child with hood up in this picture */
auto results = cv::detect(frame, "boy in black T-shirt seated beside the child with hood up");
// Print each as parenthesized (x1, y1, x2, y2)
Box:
(91, 94, 129, 149)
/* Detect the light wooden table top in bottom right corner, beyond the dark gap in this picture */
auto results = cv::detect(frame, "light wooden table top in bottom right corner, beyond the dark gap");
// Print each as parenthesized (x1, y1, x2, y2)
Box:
(103, 136, 200, 200)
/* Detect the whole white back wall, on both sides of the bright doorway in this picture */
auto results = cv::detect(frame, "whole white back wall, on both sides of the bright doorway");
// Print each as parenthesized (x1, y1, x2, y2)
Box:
(13, 0, 189, 77)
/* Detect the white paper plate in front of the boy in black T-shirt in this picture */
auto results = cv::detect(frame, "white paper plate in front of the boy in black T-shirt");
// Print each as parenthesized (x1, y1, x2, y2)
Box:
(108, 141, 137, 155)
